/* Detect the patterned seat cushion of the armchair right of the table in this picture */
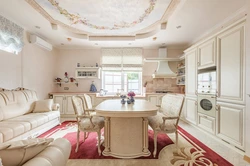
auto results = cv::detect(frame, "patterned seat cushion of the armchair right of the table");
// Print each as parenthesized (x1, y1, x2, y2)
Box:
(148, 112, 176, 133)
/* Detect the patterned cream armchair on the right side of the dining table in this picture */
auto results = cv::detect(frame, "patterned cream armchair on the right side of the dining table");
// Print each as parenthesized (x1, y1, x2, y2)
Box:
(148, 94, 184, 157)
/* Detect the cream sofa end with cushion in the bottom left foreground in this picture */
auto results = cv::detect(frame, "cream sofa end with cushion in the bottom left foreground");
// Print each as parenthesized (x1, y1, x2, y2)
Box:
(0, 138, 71, 166)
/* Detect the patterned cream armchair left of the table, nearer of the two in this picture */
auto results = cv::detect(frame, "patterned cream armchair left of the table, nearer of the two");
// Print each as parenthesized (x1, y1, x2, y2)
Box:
(72, 96, 104, 156)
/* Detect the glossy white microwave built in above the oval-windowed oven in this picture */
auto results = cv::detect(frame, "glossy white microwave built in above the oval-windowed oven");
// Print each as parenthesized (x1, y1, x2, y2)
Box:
(198, 71, 217, 94)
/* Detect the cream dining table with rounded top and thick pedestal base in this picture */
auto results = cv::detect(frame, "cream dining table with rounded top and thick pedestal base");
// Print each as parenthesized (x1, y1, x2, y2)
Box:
(95, 99, 158, 158)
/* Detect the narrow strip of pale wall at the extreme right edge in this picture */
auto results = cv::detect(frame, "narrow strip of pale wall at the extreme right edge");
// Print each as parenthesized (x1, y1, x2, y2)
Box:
(245, 0, 250, 157)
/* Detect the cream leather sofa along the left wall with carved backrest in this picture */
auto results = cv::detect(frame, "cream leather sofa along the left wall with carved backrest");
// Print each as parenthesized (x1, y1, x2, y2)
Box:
(0, 88, 60, 143)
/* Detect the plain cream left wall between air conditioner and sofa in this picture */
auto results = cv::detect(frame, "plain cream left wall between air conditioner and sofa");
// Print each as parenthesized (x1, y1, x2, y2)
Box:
(0, 32, 57, 99)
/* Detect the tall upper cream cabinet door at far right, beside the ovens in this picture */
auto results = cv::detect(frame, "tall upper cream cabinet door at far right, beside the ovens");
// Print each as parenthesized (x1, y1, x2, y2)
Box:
(217, 22, 245, 104)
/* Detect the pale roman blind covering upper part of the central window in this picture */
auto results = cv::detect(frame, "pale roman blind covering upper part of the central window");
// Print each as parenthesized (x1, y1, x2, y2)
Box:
(102, 48, 142, 71)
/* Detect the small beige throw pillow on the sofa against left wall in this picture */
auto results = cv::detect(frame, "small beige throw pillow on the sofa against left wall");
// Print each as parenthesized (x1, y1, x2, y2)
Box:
(33, 99, 53, 112)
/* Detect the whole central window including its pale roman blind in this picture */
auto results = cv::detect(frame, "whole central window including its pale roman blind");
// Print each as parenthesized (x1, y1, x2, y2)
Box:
(102, 48, 142, 94)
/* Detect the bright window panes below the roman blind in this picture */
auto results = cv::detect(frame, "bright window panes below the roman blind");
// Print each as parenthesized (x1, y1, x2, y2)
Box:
(102, 71, 142, 94)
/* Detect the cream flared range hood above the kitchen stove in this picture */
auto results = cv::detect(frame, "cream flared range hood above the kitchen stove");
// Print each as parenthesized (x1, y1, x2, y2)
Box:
(144, 48, 180, 78)
